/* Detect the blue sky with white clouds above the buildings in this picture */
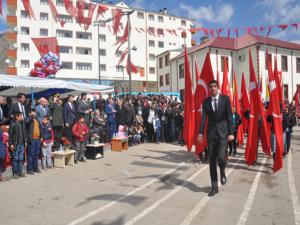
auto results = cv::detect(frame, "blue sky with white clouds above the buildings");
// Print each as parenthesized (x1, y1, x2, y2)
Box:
(0, 0, 300, 43)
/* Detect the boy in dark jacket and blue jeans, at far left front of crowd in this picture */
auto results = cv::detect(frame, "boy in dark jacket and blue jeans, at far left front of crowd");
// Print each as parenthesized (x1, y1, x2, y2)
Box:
(9, 112, 27, 178)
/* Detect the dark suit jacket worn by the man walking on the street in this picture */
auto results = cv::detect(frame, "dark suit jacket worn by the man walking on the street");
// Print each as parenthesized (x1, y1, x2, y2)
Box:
(199, 95, 233, 141)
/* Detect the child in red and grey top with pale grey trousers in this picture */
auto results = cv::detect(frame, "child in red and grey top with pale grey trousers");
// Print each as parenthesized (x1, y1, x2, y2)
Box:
(42, 116, 54, 170)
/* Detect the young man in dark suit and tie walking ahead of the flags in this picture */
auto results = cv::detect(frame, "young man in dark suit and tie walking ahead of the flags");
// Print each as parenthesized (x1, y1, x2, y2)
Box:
(198, 80, 234, 196)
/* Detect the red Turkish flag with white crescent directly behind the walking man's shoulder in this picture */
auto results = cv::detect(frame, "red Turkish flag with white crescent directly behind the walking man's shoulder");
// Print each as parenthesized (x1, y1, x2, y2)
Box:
(194, 52, 214, 154)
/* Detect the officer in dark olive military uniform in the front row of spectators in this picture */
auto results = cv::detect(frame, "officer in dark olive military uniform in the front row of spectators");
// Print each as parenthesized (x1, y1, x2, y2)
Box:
(49, 94, 64, 150)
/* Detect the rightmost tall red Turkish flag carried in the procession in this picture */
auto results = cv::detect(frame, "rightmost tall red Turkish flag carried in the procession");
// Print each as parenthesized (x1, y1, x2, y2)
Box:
(267, 50, 283, 172)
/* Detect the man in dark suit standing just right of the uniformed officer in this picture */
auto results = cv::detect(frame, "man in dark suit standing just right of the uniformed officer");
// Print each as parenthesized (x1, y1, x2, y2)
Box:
(63, 95, 75, 142)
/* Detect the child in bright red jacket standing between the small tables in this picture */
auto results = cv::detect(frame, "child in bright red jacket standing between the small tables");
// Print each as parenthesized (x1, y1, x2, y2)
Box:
(72, 115, 89, 164)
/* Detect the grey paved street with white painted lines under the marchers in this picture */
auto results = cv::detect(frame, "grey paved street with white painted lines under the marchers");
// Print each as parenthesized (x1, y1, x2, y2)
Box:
(0, 126, 300, 225)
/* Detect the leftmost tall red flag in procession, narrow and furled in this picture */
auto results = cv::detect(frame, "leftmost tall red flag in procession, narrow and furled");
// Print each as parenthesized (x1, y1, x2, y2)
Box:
(183, 48, 195, 151)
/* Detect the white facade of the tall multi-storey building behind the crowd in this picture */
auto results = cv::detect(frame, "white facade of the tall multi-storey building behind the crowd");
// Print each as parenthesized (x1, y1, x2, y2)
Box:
(12, 0, 192, 92)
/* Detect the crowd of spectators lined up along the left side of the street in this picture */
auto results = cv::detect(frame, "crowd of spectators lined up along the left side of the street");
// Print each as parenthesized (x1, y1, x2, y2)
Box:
(0, 93, 184, 179)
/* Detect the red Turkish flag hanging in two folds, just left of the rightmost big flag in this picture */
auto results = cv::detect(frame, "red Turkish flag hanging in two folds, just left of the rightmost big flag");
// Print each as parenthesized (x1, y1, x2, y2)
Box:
(245, 49, 271, 165)
